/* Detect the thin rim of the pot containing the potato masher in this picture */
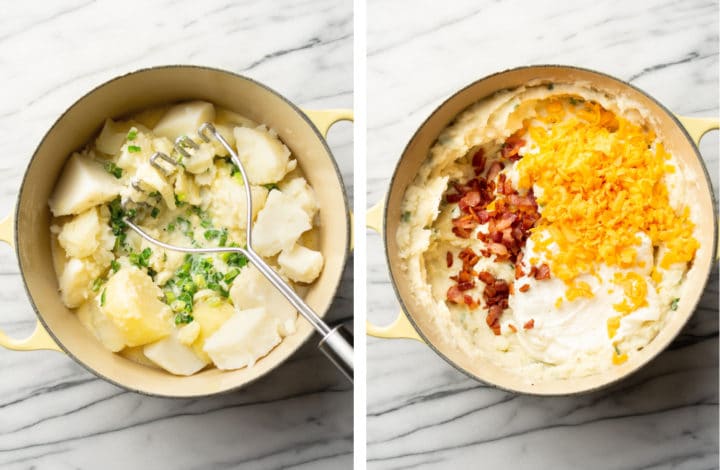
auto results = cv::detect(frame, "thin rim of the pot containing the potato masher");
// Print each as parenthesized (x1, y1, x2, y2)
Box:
(13, 64, 352, 399)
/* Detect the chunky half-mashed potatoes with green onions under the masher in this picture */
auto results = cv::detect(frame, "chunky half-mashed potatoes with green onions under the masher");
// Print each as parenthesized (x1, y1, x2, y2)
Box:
(49, 101, 324, 375)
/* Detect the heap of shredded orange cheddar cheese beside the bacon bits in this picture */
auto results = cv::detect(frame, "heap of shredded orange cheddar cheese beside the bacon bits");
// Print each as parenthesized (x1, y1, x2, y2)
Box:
(517, 99, 699, 284)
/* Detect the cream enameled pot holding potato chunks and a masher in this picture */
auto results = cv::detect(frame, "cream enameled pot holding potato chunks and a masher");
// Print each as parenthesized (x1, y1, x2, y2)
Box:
(0, 66, 352, 397)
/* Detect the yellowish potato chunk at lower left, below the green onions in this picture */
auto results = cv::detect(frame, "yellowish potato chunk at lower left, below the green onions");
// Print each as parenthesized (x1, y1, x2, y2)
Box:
(100, 267, 172, 347)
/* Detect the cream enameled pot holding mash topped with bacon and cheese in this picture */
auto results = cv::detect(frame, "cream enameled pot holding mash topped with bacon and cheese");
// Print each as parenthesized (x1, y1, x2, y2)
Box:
(367, 65, 718, 395)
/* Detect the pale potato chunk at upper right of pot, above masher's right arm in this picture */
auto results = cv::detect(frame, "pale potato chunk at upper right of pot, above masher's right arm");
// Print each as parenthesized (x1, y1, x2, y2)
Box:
(233, 126, 297, 184)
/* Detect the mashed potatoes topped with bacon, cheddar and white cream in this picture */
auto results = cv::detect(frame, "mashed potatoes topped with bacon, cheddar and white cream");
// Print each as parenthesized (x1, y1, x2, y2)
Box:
(396, 83, 700, 381)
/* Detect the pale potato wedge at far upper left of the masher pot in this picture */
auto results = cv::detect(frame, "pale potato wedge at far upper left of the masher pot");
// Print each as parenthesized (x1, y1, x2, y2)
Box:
(49, 153, 123, 217)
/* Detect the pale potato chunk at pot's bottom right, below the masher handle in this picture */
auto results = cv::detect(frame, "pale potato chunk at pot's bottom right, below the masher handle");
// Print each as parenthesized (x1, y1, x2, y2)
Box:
(205, 308, 281, 370)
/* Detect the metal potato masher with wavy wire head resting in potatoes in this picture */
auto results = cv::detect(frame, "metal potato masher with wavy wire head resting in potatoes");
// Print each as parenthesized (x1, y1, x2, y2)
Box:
(124, 122, 353, 382)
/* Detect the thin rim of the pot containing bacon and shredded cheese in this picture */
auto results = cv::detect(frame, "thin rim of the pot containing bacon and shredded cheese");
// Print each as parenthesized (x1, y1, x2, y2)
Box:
(382, 64, 718, 397)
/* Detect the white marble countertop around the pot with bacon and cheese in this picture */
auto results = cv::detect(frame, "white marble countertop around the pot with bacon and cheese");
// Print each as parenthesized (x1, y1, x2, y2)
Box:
(367, 0, 719, 470)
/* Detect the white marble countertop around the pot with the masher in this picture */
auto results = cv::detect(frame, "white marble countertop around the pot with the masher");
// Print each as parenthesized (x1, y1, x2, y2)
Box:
(0, 0, 353, 469)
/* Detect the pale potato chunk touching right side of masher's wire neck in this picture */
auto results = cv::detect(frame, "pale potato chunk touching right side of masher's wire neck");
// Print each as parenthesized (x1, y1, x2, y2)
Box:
(252, 190, 312, 257)
